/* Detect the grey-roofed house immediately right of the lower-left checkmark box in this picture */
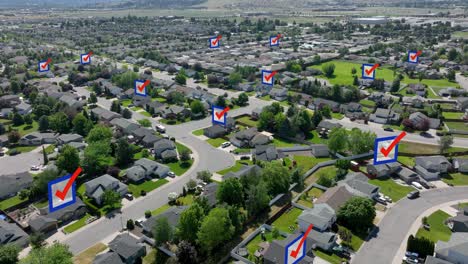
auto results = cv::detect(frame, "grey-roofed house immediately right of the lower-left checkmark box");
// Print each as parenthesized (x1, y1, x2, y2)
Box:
(85, 174, 128, 205)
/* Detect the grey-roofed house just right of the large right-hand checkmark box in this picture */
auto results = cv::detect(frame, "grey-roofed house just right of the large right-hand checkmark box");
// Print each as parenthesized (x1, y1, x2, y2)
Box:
(414, 156, 452, 181)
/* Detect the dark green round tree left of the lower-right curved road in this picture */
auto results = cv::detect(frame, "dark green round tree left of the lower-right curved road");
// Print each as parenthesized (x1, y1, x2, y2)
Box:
(337, 197, 376, 231)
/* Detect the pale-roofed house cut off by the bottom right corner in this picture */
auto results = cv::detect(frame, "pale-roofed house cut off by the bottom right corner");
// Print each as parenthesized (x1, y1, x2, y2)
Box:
(434, 232, 468, 263)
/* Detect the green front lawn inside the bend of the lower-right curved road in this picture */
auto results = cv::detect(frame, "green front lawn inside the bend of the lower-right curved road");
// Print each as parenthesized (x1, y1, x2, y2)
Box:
(416, 210, 452, 242)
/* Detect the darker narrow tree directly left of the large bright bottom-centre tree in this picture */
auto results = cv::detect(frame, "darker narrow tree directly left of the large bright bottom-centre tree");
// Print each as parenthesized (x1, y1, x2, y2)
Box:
(177, 203, 205, 243)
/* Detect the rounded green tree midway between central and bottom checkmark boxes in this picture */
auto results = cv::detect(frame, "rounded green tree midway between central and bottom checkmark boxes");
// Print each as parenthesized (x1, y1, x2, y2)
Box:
(262, 162, 290, 196)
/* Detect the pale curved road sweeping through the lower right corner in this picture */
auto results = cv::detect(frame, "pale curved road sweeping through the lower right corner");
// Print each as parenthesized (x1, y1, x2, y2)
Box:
(352, 186, 468, 264)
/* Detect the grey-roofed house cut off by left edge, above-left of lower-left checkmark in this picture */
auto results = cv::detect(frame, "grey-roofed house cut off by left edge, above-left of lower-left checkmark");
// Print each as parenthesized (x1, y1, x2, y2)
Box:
(0, 172, 33, 199)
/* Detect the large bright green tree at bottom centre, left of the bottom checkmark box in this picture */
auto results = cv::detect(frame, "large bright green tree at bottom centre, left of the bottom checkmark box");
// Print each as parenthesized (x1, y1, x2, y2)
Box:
(197, 208, 234, 253)
